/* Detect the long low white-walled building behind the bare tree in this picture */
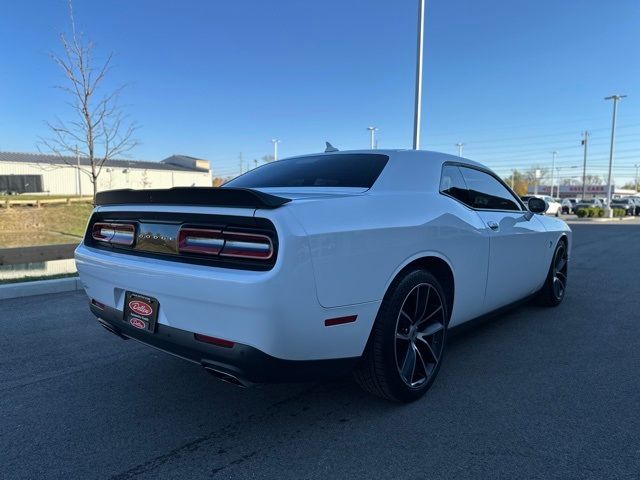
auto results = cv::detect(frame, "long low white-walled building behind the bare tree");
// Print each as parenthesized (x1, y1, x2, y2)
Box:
(0, 152, 211, 195)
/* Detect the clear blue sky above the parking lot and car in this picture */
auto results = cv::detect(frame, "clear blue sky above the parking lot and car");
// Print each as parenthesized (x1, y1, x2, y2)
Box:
(0, 0, 640, 183)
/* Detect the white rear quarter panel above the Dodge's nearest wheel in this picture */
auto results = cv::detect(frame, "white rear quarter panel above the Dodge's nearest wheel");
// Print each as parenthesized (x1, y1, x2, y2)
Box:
(284, 192, 489, 323)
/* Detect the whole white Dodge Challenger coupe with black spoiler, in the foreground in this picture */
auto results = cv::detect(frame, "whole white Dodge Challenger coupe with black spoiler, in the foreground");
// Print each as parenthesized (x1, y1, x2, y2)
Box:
(75, 150, 571, 401)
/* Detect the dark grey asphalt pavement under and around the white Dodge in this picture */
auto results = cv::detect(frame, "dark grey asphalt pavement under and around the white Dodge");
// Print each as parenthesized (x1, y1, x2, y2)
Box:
(0, 222, 640, 480)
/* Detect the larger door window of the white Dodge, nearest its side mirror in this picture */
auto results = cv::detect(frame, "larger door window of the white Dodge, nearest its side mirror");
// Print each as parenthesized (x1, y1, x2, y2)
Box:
(460, 167, 521, 211)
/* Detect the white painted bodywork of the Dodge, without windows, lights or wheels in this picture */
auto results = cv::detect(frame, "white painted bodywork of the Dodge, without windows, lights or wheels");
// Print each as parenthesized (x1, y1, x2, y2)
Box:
(76, 150, 571, 360)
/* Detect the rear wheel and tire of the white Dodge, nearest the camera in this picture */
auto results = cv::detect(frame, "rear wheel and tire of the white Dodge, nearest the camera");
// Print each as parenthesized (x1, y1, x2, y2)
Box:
(354, 270, 449, 402)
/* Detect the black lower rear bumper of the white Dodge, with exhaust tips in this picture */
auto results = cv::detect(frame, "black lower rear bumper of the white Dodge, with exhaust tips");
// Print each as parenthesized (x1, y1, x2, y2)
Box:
(89, 304, 359, 385)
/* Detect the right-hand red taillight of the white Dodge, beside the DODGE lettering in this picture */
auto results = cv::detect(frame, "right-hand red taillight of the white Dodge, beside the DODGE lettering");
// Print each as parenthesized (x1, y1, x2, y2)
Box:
(178, 227, 273, 260)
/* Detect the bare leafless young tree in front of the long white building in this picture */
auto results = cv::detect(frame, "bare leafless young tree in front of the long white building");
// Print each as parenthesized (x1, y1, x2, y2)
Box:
(40, 1, 138, 203)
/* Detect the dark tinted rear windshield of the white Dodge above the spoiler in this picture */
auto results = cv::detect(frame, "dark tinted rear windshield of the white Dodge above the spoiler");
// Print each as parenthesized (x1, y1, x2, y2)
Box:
(225, 153, 389, 188)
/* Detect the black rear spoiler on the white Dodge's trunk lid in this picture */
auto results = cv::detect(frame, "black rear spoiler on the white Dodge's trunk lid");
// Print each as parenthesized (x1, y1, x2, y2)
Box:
(96, 187, 291, 209)
